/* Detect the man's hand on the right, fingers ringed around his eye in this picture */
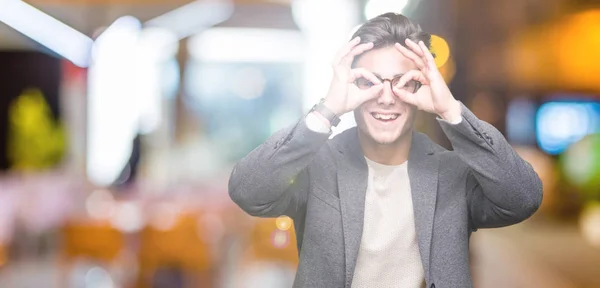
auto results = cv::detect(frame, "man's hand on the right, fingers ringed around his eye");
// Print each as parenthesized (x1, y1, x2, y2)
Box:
(394, 39, 461, 123)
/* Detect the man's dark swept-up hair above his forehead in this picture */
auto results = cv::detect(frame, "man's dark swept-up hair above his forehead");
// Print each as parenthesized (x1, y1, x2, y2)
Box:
(351, 12, 435, 64)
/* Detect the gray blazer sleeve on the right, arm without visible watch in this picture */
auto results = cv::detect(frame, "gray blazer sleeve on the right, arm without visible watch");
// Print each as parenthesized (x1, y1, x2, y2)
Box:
(438, 103, 542, 231)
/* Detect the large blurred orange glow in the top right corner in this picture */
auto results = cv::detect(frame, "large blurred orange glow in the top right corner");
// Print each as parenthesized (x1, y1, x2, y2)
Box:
(504, 9, 600, 91)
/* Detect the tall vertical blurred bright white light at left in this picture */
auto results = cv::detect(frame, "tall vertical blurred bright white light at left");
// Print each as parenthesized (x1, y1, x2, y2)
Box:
(87, 16, 141, 186)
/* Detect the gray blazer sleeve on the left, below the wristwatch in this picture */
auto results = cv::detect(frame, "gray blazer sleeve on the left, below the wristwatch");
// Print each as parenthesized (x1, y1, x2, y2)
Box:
(228, 118, 331, 218)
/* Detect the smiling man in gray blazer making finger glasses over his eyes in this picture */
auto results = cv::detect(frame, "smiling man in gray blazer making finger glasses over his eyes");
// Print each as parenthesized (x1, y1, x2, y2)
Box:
(229, 13, 542, 288)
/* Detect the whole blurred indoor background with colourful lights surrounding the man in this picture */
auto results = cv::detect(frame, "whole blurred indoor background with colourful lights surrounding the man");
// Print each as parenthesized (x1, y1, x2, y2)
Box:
(0, 0, 600, 288)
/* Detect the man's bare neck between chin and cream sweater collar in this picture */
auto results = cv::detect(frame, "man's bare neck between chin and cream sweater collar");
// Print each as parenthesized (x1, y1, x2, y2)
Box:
(358, 132, 412, 166)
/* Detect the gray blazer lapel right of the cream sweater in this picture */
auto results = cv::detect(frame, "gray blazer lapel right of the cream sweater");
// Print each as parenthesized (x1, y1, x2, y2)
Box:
(408, 132, 439, 283)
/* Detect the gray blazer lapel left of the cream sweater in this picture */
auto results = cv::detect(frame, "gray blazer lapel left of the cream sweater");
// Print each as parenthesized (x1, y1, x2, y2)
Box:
(337, 129, 368, 288)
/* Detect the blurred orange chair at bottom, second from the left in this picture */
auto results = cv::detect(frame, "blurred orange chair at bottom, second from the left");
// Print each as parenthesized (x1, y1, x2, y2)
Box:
(138, 213, 215, 287)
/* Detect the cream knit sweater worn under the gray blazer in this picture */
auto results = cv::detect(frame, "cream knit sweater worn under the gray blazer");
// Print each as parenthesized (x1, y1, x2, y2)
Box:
(352, 159, 425, 288)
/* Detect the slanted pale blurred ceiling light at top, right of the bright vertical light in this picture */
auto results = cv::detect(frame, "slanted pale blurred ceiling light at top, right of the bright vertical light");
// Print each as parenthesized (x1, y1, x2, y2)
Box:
(145, 0, 234, 40)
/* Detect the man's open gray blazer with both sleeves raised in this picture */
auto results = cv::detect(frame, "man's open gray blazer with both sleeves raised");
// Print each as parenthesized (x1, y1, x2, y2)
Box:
(229, 104, 542, 288)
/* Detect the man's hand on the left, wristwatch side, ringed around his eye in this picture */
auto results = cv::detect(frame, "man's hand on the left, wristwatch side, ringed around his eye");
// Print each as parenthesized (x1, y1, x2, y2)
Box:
(324, 37, 383, 116)
